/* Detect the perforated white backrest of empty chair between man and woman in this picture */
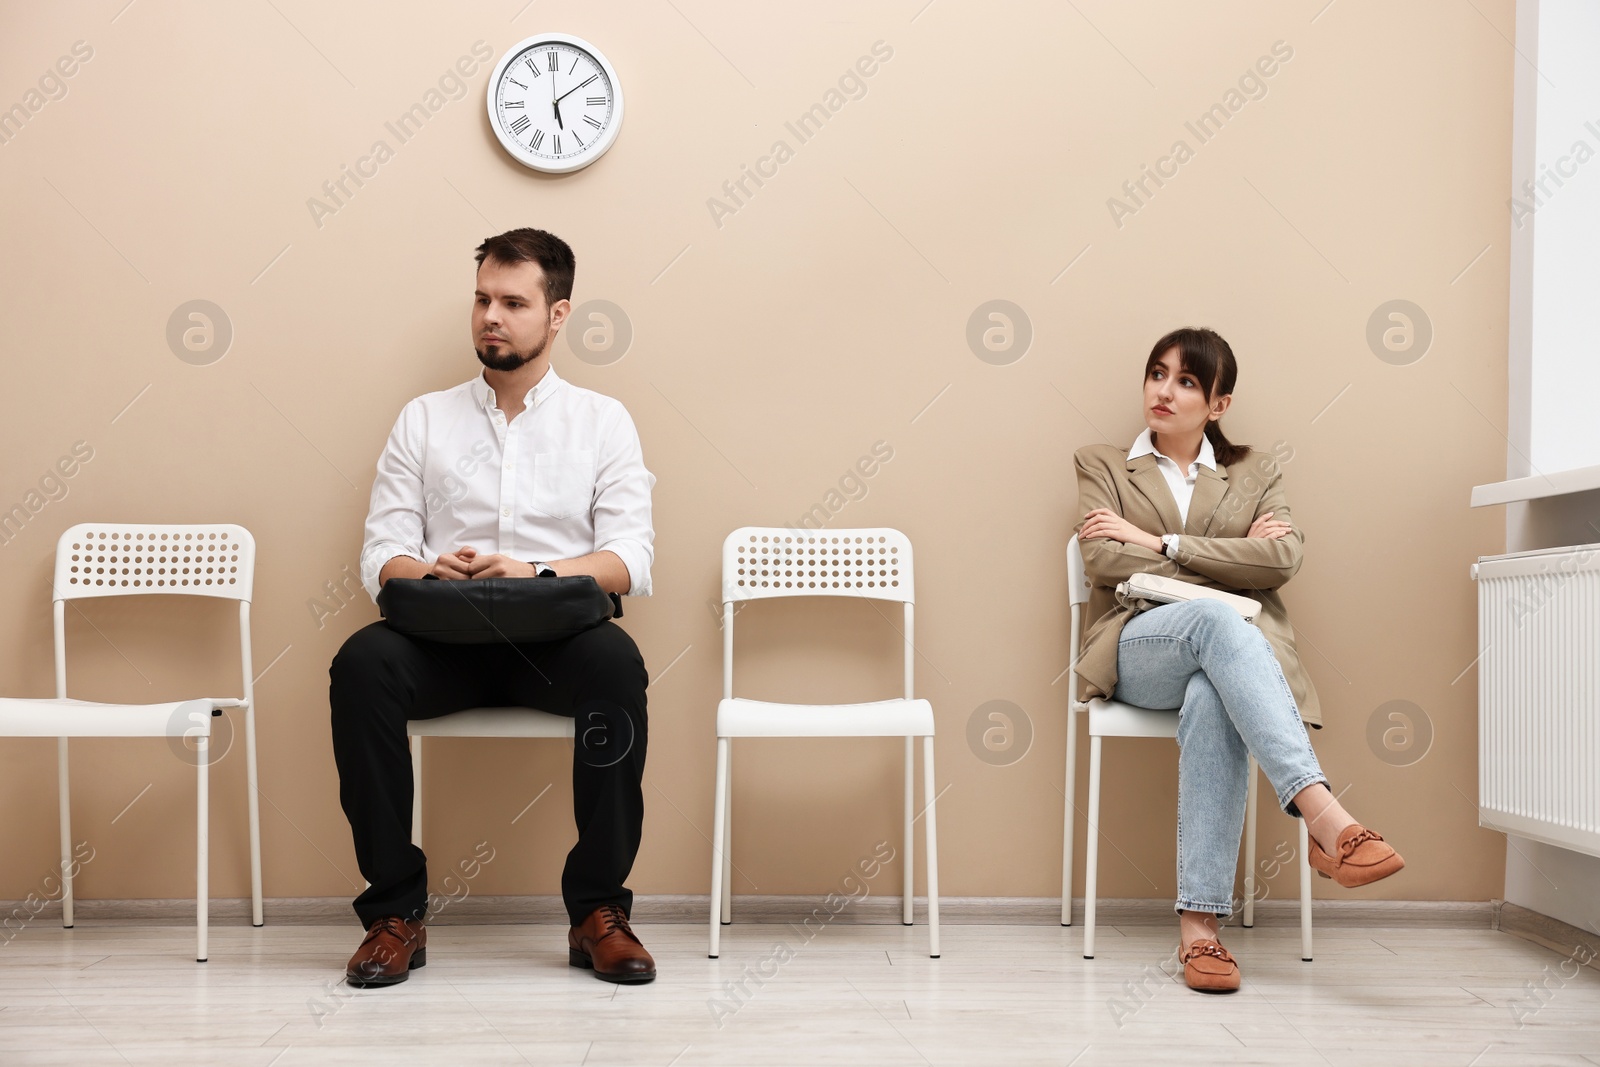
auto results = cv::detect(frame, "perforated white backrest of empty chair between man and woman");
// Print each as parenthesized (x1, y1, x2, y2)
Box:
(722, 526, 914, 605)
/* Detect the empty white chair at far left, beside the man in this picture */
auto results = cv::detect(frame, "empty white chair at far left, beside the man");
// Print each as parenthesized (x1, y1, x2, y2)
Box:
(0, 523, 264, 963)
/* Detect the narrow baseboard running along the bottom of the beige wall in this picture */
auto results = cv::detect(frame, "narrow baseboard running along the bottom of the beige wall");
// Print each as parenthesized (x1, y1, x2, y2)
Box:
(0, 894, 1497, 927)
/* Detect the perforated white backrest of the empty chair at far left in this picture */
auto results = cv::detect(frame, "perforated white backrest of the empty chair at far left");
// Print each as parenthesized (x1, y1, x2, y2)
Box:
(51, 523, 256, 601)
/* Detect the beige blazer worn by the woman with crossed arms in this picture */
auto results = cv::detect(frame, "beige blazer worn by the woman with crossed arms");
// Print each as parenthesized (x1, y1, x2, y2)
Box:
(1074, 445, 1322, 729)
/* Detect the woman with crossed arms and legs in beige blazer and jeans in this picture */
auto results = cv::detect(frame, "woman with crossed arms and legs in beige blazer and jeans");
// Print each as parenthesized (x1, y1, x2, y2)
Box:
(1077, 330, 1405, 992)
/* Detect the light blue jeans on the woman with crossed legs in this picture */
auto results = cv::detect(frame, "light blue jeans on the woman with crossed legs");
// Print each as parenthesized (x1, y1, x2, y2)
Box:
(1114, 600, 1328, 918)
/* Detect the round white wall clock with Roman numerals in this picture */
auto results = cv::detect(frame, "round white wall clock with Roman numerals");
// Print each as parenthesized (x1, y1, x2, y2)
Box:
(488, 34, 622, 173)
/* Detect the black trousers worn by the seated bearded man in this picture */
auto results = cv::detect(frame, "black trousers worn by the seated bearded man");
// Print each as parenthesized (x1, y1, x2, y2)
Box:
(328, 622, 650, 926)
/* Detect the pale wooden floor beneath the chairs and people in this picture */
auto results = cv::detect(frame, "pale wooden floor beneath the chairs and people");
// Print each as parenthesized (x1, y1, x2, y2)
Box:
(0, 921, 1600, 1067)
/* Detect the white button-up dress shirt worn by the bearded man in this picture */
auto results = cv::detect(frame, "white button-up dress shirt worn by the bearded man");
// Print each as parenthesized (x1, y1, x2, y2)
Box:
(362, 366, 656, 600)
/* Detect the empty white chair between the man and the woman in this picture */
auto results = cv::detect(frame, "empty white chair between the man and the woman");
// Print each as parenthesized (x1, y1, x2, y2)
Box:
(710, 526, 939, 960)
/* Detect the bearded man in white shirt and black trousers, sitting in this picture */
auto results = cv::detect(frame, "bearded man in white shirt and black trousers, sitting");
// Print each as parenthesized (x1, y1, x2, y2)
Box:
(328, 229, 656, 985)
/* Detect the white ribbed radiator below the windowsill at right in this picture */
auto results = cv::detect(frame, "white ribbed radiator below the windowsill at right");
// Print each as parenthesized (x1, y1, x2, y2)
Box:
(1472, 544, 1600, 856)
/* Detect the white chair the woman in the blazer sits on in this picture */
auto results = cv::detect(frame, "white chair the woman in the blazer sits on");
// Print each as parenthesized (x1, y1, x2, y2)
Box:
(1061, 536, 1310, 963)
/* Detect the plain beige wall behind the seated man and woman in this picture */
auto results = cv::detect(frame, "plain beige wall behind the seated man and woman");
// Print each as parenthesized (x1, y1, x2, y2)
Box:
(0, 0, 1512, 899)
